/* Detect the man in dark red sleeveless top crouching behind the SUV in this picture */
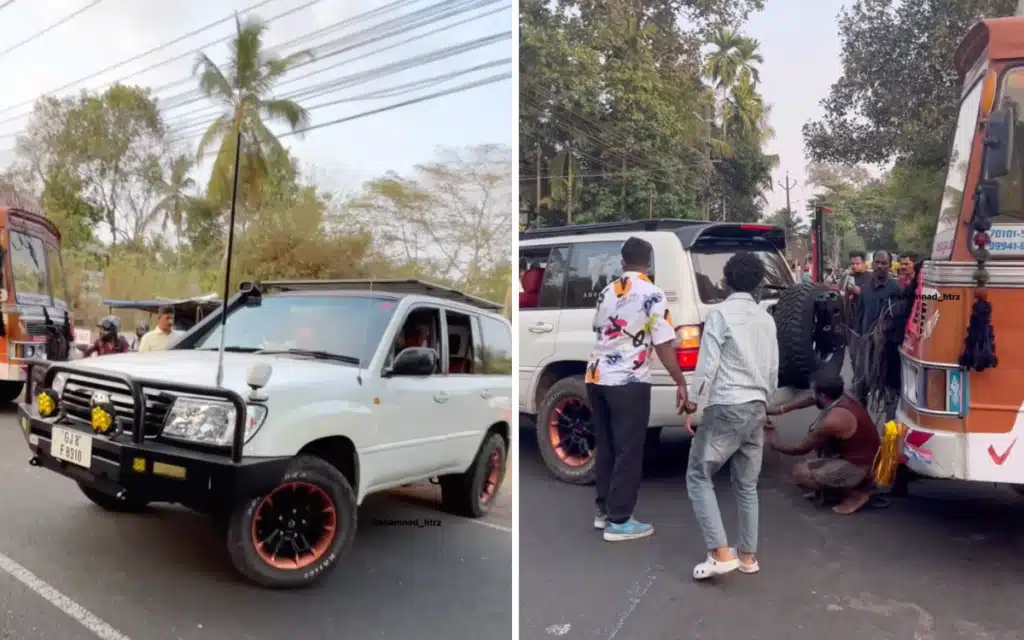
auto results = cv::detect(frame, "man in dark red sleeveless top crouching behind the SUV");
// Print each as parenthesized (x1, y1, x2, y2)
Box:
(765, 371, 882, 515)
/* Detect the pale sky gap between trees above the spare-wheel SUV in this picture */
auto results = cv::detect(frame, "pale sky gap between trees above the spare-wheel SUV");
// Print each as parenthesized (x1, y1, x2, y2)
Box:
(743, 0, 850, 219)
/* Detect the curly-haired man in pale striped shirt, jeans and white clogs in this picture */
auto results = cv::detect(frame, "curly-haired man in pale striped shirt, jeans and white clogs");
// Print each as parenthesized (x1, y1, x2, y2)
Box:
(686, 251, 778, 580)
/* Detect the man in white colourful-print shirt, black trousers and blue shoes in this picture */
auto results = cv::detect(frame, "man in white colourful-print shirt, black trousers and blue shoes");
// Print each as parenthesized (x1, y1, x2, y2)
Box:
(586, 238, 695, 542)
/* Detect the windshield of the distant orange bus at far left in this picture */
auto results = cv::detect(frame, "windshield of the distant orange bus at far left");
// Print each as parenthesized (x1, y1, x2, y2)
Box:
(7, 230, 67, 308)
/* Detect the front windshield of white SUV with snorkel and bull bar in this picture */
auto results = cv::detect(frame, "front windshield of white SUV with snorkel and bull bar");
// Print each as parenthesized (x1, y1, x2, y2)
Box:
(195, 295, 397, 364)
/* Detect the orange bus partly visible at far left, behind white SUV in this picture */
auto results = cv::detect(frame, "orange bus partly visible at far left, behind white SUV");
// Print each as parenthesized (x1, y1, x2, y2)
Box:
(0, 207, 74, 402)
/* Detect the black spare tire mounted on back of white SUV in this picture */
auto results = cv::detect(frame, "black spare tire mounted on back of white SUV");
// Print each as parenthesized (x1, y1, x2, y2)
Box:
(772, 283, 846, 389)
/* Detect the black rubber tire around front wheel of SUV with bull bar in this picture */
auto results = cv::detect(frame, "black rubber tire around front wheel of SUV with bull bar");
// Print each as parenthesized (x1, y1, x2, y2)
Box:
(227, 455, 357, 589)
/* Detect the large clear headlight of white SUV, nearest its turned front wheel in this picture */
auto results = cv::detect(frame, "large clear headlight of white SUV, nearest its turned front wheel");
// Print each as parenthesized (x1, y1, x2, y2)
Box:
(163, 397, 266, 446)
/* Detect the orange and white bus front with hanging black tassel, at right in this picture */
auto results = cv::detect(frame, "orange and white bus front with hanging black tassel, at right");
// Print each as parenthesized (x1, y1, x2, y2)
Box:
(896, 17, 1024, 490)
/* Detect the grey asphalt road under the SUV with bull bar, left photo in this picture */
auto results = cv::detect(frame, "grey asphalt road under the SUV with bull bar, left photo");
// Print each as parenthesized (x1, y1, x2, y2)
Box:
(0, 409, 513, 640)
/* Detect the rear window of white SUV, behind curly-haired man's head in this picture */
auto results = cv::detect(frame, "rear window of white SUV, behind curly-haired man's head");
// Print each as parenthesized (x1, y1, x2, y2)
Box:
(690, 240, 793, 304)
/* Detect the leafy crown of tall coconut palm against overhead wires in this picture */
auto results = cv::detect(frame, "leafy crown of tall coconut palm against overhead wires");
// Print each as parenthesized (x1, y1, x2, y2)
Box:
(193, 18, 313, 206)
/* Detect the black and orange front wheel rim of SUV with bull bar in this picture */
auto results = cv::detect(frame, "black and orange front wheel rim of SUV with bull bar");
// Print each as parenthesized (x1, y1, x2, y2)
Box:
(252, 482, 338, 570)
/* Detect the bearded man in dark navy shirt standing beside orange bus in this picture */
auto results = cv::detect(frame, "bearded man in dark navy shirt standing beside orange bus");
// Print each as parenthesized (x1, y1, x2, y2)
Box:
(853, 251, 903, 407)
